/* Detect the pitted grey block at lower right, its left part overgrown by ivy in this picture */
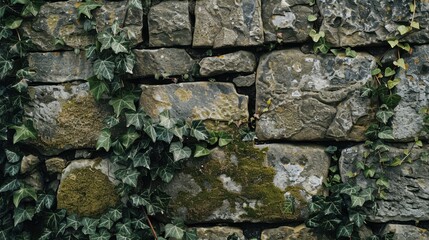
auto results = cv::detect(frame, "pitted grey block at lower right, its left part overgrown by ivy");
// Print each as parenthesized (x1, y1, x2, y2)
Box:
(340, 145, 429, 222)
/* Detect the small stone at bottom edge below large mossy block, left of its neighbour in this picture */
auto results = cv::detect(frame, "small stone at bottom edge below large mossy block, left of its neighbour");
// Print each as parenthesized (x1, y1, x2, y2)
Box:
(196, 227, 245, 240)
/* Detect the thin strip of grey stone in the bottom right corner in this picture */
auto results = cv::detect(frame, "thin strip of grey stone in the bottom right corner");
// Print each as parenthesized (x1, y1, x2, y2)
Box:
(383, 224, 429, 240)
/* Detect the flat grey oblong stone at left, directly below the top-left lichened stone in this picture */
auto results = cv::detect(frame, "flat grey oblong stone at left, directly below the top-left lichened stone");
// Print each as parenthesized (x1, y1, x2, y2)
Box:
(28, 51, 94, 83)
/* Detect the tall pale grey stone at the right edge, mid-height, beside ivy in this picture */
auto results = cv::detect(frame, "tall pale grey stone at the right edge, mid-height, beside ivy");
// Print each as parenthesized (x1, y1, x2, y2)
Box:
(392, 45, 429, 141)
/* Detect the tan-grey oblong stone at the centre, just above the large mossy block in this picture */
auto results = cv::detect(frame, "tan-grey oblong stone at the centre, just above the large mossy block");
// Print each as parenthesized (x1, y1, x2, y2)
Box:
(140, 82, 249, 122)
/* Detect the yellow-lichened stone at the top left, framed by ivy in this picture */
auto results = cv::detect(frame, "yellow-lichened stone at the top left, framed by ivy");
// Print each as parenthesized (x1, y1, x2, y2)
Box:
(22, 1, 95, 51)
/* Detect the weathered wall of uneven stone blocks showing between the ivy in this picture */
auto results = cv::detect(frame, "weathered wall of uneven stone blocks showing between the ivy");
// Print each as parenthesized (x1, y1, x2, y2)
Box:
(21, 0, 429, 239)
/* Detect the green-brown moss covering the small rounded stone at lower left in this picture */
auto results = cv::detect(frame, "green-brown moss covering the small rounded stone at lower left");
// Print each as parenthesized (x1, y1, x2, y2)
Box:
(57, 168, 119, 216)
